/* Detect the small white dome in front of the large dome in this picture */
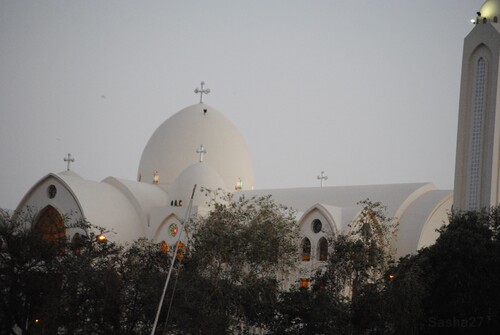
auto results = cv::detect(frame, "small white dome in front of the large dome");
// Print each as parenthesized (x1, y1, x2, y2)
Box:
(169, 162, 227, 206)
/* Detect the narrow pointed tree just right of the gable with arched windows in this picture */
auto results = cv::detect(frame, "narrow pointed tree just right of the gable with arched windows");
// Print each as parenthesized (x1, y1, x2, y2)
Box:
(316, 199, 397, 334)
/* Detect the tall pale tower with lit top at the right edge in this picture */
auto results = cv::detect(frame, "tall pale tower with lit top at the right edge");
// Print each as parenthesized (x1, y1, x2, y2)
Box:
(453, 0, 500, 210)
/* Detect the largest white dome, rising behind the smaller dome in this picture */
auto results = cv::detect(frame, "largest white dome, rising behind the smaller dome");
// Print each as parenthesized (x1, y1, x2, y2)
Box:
(138, 103, 254, 192)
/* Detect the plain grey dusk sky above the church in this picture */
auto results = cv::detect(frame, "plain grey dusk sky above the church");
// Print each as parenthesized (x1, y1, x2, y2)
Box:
(0, 0, 484, 208)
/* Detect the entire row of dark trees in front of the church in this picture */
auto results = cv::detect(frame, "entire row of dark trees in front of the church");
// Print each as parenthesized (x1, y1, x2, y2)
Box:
(0, 200, 500, 334)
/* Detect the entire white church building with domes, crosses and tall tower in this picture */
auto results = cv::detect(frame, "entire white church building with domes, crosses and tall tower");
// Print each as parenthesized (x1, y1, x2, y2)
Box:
(13, 0, 500, 265)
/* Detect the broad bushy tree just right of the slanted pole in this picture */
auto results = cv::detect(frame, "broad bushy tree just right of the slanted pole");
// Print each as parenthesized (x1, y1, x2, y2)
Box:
(164, 191, 298, 334)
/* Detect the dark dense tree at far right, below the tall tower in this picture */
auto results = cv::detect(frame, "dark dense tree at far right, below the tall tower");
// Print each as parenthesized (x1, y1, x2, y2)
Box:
(387, 207, 500, 334)
